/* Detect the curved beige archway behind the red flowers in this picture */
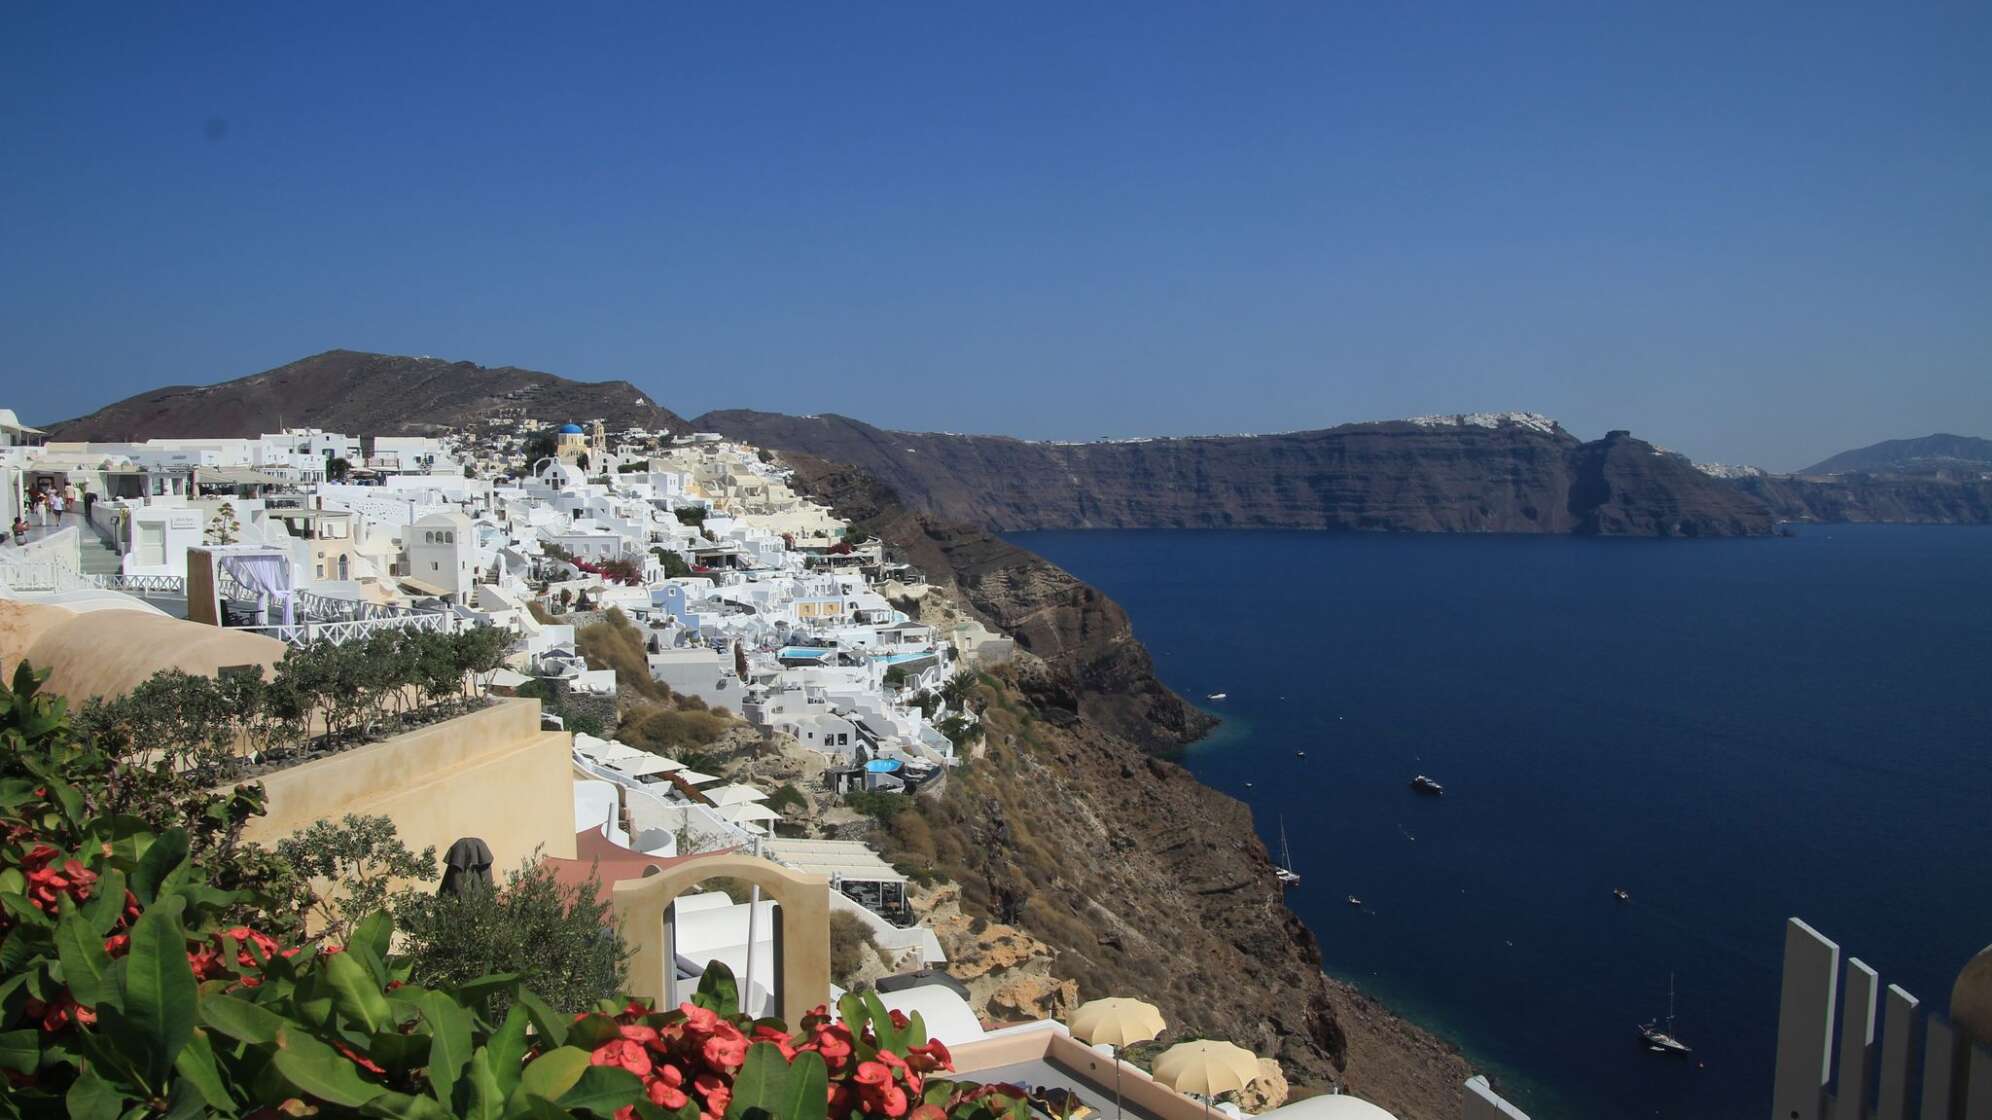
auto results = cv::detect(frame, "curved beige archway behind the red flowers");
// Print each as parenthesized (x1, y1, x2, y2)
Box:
(610, 853, 831, 1022)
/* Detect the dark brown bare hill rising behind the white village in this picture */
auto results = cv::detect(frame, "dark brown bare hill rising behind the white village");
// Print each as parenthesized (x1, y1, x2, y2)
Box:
(44, 351, 689, 440)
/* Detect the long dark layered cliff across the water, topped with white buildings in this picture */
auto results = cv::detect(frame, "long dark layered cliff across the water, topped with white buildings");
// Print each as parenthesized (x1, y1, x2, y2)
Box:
(695, 413, 1773, 536)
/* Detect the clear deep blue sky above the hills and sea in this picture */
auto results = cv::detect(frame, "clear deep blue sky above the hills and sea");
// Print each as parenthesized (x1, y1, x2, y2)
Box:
(0, 2, 1992, 468)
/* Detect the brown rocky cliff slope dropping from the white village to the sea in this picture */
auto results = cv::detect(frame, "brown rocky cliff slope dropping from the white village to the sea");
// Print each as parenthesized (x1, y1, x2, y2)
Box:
(783, 454, 1468, 1120)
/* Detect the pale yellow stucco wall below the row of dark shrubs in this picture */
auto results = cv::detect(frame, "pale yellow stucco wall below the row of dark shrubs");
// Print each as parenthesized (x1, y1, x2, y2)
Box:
(245, 700, 574, 881)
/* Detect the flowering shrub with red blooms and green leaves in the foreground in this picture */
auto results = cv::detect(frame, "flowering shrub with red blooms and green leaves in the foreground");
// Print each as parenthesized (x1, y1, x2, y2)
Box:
(0, 670, 1024, 1120)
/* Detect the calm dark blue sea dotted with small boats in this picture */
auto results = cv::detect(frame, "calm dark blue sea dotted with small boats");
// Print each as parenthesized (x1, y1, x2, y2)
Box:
(1014, 526, 1992, 1120)
